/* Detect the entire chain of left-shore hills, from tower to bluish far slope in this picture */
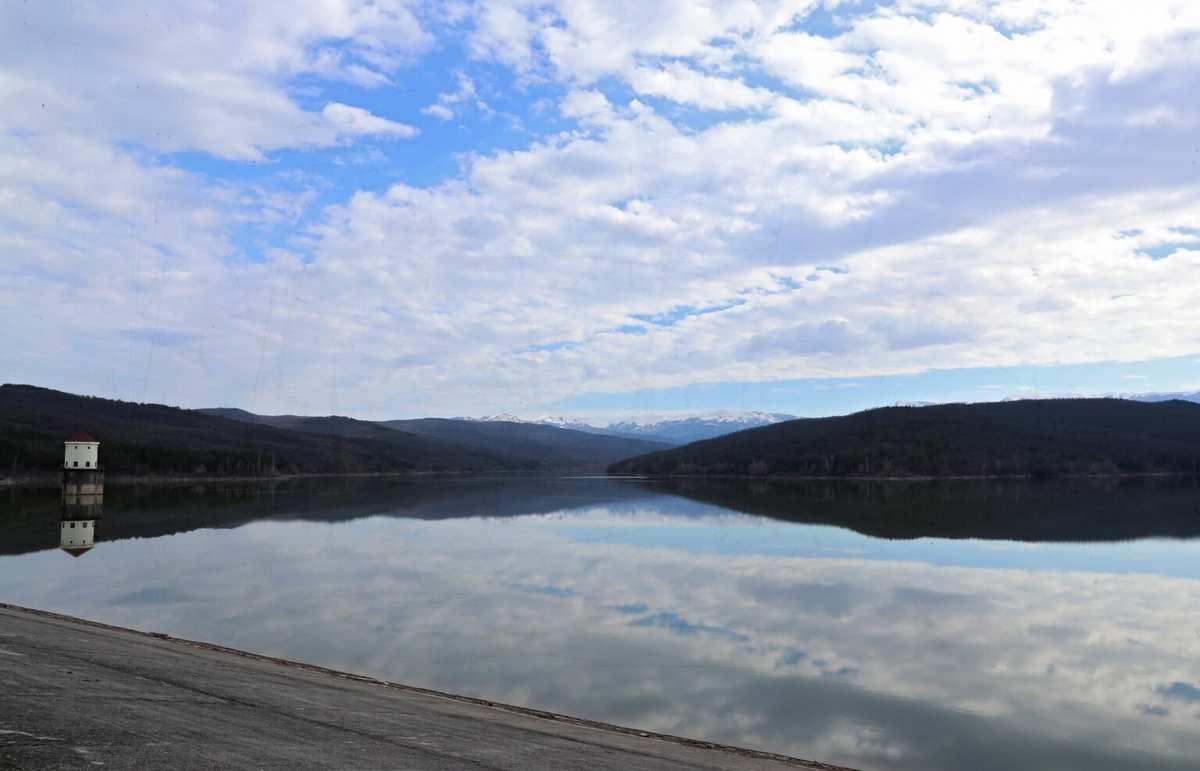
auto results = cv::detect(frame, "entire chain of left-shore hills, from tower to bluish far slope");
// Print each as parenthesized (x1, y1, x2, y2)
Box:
(0, 384, 670, 478)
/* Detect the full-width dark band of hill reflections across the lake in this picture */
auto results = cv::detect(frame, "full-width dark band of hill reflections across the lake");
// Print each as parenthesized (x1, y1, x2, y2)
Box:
(0, 470, 1200, 555)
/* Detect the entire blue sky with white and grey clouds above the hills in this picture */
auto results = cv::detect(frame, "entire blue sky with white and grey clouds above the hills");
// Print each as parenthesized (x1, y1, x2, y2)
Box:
(0, 0, 1200, 422)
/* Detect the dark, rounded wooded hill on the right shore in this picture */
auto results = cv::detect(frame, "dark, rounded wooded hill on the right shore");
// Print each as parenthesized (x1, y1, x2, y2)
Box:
(608, 399, 1200, 477)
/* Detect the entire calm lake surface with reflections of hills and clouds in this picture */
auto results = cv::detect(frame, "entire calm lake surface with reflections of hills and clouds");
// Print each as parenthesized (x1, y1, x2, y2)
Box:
(0, 478, 1200, 771)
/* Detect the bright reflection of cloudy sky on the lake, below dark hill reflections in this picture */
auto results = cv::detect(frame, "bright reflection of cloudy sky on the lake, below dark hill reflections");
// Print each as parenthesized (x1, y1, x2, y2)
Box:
(0, 489, 1200, 770)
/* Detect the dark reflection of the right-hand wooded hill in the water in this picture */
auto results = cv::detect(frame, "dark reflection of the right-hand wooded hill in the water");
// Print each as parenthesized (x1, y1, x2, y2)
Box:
(661, 477, 1200, 542)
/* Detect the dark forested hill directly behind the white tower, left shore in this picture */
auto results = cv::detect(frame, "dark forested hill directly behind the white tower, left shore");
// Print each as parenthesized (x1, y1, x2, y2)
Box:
(0, 384, 539, 476)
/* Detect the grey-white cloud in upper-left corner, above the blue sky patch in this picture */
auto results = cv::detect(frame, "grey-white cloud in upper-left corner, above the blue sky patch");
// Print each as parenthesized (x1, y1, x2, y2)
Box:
(0, 1, 431, 160)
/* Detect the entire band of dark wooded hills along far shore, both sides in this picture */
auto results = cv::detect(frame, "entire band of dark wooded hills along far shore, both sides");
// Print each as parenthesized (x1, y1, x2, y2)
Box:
(0, 384, 1200, 484)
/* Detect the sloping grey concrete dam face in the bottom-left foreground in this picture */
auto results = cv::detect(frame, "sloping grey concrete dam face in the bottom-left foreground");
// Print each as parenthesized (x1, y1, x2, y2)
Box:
(0, 604, 835, 771)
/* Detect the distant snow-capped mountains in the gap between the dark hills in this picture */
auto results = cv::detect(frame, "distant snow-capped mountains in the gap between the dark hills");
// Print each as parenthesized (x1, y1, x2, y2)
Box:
(456, 410, 797, 444)
